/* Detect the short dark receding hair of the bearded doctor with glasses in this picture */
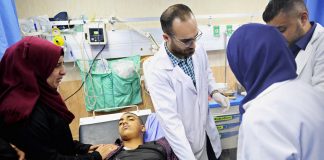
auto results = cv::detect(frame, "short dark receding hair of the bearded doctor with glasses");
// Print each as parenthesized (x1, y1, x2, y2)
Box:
(160, 4, 194, 35)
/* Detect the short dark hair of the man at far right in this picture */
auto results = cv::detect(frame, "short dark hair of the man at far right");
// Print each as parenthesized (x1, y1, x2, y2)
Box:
(262, 0, 307, 23)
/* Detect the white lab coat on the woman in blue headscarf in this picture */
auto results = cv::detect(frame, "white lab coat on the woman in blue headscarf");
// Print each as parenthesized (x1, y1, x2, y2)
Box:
(237, 80, 324, 160)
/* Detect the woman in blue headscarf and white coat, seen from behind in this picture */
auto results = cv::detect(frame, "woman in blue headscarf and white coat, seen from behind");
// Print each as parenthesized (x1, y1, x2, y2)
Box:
(227, 24, 324, 160)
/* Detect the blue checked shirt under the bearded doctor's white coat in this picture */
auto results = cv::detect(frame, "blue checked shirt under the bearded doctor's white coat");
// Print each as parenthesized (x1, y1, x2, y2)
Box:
(164, 44, 196, 86)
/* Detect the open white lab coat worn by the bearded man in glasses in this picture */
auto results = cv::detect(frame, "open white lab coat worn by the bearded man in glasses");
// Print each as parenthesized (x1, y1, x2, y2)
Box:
(144, 45, 221, 160)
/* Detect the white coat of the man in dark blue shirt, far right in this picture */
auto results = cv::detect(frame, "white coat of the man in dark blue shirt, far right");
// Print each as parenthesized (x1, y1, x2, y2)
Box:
(295, 23, 324, 92)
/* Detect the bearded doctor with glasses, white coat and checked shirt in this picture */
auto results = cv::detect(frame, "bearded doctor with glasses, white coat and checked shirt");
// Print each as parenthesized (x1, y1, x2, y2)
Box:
(144, 4, 229, 160)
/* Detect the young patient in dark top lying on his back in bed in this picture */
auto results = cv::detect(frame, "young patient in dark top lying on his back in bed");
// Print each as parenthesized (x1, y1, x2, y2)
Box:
(106, 112, 178, 160)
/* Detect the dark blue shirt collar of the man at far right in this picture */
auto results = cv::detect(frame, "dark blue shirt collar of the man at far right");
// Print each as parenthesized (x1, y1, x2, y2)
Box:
(290, 22, 316, 57)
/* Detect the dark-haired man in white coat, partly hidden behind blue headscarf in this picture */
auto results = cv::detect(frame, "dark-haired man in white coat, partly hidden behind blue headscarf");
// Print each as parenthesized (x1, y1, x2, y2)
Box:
(263, 0, 324, 92)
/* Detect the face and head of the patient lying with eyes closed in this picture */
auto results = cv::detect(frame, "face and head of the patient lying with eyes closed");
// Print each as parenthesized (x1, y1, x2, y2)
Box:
(118, 113, 145, 141)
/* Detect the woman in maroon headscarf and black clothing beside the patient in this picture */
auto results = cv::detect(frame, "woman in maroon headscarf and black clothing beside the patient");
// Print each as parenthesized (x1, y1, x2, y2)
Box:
(0, 37, 116, 160)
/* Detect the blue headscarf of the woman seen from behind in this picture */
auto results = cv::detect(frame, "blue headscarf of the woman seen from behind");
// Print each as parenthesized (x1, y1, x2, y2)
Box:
(227, 23, 297, 114)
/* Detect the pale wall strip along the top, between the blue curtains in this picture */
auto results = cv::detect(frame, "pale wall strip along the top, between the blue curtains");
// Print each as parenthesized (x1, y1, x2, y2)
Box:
(16, 0, 268, 20)
